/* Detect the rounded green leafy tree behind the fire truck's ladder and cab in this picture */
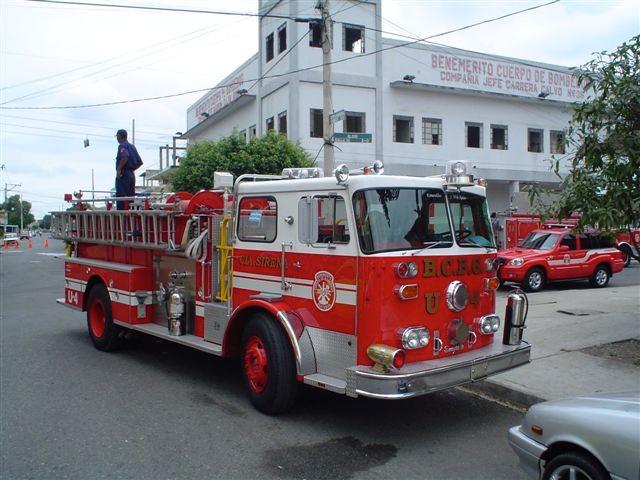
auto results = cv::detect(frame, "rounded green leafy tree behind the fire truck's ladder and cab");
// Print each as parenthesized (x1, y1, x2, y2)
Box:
(172, 132, 313, 193)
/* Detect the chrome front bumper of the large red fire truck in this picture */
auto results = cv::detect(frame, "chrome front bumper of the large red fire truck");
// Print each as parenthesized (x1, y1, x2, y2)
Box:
(345, 340, 531, 400)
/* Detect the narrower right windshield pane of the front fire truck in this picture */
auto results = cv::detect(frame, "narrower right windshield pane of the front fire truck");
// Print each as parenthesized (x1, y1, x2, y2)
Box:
(447, 191, 496, 248)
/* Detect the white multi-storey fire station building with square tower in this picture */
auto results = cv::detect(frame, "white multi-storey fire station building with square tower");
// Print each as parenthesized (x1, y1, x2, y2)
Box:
(183, 0, 584, 211)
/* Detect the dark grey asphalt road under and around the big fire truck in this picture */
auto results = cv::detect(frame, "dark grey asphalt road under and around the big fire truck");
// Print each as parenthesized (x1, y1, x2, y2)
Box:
(0, 239, 640, 480)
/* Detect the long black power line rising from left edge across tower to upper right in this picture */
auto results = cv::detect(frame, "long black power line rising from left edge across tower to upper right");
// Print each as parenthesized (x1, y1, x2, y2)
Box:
(0, 0, 560, 110)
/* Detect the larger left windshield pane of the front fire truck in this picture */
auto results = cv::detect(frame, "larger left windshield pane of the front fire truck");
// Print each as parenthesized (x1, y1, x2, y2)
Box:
(353, 188, 453, 253)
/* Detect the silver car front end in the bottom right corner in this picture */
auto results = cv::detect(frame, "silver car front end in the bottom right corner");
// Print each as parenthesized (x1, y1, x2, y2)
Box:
(509, 391, 640, 480)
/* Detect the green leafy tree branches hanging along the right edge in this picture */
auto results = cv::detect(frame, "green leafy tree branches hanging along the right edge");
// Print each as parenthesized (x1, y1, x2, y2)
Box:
(530, 36, 640, 261)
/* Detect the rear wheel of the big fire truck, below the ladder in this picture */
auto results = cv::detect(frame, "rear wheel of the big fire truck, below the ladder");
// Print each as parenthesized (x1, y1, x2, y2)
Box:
(87, 284, 122, 352)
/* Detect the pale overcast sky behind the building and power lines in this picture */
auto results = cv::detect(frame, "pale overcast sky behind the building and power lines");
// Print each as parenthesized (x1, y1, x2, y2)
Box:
(0, 0, 640, 218)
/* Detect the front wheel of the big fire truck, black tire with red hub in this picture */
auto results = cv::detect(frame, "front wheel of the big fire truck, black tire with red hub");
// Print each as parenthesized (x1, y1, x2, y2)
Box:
(240, 313, 298, 415)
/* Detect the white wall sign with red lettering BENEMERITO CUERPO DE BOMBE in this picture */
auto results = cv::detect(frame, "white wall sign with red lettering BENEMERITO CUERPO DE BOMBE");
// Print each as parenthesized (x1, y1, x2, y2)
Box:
(427, 53, 585, 102)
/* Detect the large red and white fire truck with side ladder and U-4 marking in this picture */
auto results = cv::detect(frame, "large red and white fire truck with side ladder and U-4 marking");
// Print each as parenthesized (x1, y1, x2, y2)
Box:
(53, 161, 530, 414)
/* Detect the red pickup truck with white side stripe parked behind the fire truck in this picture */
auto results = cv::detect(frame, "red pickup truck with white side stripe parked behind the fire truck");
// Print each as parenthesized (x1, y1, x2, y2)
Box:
(498, 228, 624, 292)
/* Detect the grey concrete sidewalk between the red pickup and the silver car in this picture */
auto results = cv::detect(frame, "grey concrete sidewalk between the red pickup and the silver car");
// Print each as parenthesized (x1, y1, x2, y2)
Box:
(468, 269, 640, 406)
